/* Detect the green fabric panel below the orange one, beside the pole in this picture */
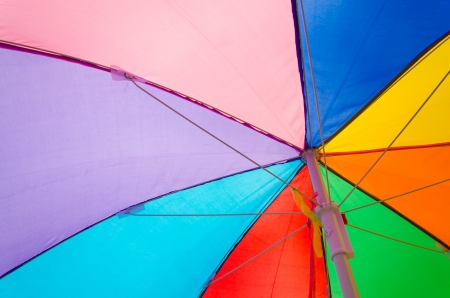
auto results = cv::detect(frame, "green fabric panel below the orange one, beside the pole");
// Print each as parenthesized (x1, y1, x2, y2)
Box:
(321, 168, 450, 298)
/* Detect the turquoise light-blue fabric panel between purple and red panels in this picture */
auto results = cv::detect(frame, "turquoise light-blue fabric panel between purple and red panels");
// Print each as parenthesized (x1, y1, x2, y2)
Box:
(0, 161, 302, 298)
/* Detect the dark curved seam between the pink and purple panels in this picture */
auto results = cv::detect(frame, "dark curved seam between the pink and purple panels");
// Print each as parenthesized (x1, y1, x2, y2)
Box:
(0, 40, 303, 152)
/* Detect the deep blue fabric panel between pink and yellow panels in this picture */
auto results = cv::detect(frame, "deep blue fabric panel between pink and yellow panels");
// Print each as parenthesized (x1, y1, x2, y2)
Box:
(296, 0, 450, 146)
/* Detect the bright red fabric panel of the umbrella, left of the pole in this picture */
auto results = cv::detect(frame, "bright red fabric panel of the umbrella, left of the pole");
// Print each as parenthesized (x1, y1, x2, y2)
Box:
(203, 167, 327, 298)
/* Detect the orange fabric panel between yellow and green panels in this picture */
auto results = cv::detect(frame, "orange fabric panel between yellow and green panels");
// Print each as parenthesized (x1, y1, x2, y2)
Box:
(327, 143, 450, 244)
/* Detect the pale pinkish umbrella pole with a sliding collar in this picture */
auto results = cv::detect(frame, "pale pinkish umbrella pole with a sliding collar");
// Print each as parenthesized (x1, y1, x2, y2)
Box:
(303, 150, 359, 298)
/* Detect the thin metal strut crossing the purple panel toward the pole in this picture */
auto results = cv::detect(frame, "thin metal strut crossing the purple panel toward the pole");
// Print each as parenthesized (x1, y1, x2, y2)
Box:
(130, 78, 317, 204)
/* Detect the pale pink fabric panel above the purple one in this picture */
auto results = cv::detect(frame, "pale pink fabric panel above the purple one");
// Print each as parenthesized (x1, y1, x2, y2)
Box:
(0, 0, 305, 147)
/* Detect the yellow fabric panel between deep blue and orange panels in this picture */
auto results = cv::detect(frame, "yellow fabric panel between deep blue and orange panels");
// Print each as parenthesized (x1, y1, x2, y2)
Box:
(325, 35, 450, 152)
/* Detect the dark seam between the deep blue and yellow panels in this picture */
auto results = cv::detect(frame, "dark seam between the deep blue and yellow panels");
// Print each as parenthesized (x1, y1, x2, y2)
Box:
(315, 31, 450, 149)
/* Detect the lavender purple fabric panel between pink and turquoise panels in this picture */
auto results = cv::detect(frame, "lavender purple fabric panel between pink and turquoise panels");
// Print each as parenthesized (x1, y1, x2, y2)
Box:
(0, 49, 298, 276)
